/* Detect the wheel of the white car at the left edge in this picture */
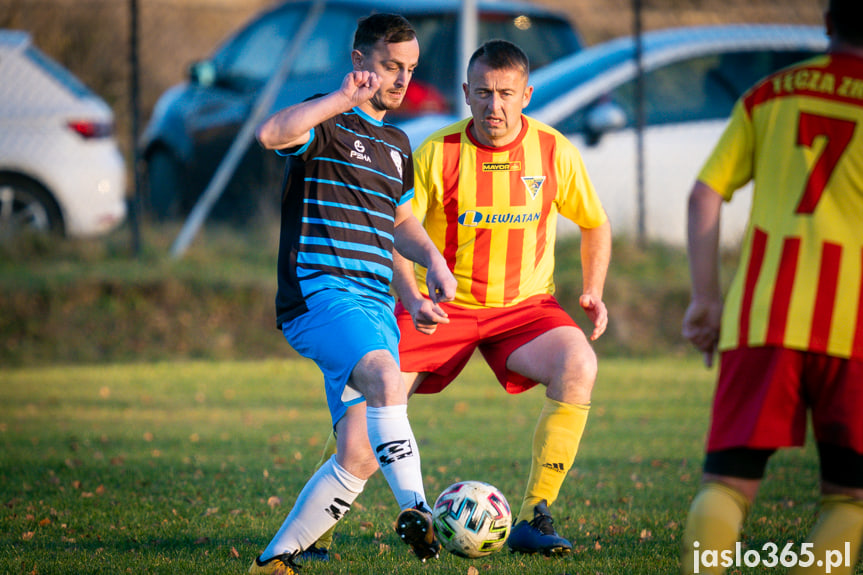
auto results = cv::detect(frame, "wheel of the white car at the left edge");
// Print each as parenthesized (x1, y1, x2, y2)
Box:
(0, 175, 64, 240)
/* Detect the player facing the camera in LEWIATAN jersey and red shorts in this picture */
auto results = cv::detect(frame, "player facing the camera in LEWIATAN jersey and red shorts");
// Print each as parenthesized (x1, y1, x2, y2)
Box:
(394, 40, 611, 555)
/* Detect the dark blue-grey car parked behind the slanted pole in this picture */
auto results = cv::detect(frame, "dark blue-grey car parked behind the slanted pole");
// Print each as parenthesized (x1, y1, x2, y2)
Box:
(141, 0, 582, 222)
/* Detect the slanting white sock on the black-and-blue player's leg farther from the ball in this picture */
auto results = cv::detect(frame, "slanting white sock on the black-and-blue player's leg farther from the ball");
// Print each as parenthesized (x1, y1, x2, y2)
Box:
(261, 455, 366, 561)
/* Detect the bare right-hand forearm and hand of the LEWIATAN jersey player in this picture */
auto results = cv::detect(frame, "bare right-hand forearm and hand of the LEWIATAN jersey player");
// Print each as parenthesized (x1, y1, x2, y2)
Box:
(578, 220, 611, 341)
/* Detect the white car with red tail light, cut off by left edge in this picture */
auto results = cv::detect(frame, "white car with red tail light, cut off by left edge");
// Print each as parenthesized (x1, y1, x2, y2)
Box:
(0, 30, 126, 240)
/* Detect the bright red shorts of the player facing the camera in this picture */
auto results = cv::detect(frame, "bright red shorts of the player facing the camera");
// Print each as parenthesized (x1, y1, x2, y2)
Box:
(396, 295, 578, 393)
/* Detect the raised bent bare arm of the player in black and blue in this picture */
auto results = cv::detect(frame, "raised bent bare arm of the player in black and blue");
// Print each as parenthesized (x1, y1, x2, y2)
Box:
(255, 70, 380, 150)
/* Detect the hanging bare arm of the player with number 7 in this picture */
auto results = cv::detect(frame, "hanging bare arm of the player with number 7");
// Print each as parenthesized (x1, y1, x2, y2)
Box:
(683, 181, 722, 367)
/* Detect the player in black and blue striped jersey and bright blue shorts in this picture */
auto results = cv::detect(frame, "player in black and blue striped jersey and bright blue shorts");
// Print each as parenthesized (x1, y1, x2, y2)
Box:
(249, 14, 455, 575)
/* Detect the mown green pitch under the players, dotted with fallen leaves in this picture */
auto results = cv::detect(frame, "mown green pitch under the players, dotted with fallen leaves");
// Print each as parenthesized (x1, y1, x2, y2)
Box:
(0, 358, 836, 575)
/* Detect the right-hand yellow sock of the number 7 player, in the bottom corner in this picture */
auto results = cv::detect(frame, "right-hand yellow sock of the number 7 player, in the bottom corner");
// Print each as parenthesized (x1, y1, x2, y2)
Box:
(788, 495, 863, 575)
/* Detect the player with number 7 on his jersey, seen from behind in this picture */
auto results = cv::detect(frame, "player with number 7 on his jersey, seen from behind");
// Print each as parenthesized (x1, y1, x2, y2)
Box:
(681, 0, 863, 575)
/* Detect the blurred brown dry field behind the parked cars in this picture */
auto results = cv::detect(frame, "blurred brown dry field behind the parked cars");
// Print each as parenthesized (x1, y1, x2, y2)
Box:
(0, 0, 826, 173)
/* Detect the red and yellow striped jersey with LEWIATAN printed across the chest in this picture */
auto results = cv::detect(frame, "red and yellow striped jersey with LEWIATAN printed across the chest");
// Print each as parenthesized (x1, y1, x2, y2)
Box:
(412, 116, 606, 308)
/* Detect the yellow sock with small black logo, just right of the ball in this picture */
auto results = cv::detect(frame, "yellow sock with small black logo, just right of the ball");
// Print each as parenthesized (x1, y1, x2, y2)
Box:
(515, 397, 590, 523)
